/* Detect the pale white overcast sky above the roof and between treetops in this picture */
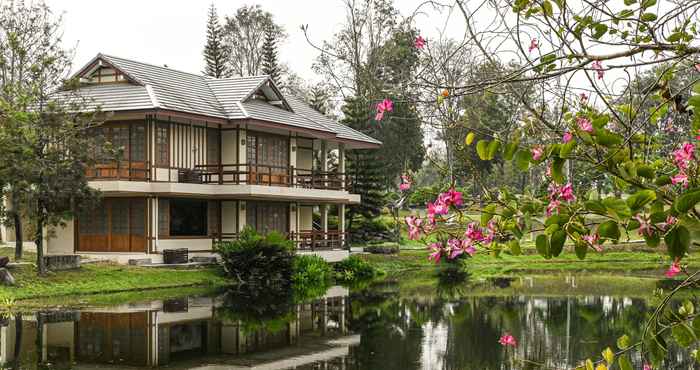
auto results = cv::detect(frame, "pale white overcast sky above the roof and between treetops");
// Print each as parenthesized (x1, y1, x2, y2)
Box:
(47, 0, 463, 81)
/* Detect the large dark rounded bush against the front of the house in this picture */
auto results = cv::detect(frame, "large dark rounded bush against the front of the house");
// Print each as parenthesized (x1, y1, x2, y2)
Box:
(214, 227, 295, 287)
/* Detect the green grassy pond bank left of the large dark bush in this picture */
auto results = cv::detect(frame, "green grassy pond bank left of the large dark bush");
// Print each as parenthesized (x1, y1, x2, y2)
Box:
(0, 263, 226, 305)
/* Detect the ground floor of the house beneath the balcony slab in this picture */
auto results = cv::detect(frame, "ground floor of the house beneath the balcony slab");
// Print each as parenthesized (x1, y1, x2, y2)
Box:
(2, 196, 348, 263)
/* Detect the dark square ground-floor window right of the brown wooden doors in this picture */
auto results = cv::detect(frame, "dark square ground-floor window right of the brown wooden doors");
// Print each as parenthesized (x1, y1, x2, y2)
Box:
(170, 199, 208, 236)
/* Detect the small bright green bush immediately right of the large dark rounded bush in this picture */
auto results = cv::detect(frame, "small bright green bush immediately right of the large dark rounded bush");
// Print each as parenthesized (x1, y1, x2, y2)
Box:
(292, 255, 334, 300)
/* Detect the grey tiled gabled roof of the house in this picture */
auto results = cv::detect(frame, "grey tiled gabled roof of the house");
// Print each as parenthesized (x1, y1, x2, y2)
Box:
(68, 54, 381, 146)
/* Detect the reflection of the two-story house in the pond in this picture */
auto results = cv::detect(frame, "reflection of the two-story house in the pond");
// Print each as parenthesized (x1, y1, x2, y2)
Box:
(0, 287, 352, 369)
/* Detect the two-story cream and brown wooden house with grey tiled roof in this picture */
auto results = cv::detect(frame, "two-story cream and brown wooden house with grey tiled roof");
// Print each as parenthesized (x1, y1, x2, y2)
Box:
(27, 54, 381, 262)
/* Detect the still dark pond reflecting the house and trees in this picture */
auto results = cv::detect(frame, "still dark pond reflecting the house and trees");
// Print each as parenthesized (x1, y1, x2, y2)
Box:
(0, 276, 694, 370)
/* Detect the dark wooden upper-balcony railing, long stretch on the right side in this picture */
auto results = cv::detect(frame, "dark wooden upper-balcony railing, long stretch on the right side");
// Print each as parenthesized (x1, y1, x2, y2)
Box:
(190, 164, 345, 190)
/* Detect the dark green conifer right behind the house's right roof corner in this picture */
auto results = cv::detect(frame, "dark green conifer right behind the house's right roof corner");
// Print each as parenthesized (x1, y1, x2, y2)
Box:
(341, 97, 384, 232)
